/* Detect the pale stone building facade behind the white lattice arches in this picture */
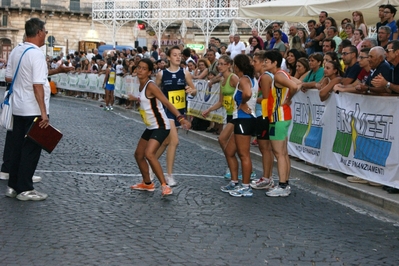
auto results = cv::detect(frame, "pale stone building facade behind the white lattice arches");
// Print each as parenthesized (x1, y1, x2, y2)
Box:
(0, 0, 255, 59)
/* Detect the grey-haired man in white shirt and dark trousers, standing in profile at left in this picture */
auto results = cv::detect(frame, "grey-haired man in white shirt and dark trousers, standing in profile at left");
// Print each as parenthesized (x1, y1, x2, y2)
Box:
(5, 18, 66, 201)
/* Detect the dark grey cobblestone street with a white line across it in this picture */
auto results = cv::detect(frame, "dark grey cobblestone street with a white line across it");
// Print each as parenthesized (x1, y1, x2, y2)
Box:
(0, 97, 399, 266)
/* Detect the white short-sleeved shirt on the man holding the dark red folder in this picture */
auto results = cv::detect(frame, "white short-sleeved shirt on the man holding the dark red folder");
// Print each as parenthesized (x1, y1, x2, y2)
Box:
(6, 42, 51, 116)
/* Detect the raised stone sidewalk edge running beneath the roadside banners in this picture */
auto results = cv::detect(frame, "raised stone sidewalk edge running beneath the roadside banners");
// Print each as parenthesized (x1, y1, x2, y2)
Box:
(184, 124, 399, 214)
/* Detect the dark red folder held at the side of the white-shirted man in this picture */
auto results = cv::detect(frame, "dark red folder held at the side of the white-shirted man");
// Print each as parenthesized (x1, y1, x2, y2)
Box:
(25, 117, 62, 153)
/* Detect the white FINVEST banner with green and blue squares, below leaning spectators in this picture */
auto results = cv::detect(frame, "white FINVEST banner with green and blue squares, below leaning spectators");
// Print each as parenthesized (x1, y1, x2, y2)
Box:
(288, 90, 399, 188)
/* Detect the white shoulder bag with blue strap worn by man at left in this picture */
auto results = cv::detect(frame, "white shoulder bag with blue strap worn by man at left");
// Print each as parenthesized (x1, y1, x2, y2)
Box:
(0, 46, 33, 130)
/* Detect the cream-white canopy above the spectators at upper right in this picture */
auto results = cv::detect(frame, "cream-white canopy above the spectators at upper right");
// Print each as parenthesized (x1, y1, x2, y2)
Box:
(239, 0, 399, 25)
